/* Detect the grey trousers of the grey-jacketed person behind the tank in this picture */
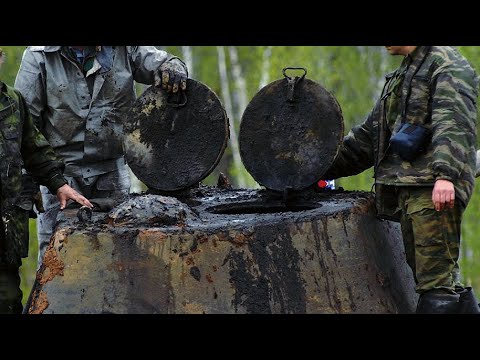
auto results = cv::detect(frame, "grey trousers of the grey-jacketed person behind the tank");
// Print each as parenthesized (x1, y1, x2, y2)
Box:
(37, 167, 130, 268)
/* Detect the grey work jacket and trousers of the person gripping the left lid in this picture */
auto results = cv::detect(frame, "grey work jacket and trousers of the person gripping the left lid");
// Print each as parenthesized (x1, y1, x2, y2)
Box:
(15, 46, 186, 266)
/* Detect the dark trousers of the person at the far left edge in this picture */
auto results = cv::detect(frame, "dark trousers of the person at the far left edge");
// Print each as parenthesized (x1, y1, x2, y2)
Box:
(0, 257, 23, 314)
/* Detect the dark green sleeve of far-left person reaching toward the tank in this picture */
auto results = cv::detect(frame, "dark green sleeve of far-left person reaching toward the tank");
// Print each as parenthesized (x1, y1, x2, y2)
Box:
(17, 92, 67, 194)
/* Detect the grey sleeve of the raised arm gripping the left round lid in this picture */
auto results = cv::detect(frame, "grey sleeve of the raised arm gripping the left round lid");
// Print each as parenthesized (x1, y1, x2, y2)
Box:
(127, 46, 187, 85)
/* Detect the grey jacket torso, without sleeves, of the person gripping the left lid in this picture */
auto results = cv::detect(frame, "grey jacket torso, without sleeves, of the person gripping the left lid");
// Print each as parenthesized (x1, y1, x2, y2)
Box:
(35, 47, 135, 177)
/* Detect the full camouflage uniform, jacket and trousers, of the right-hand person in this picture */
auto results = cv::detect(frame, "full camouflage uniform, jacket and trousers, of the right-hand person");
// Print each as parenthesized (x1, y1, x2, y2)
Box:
(324, 46, 478, 294)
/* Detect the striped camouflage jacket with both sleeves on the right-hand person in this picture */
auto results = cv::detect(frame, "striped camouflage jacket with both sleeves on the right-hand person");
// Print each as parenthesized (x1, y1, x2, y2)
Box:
(324, 46, 478, 217)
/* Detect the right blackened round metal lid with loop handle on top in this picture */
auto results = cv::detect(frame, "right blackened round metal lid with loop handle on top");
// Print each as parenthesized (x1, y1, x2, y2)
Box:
(239, 78, 343, 191)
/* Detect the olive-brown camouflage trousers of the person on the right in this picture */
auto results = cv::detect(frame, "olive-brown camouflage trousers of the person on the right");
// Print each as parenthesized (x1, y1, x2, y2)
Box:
(396, 187, 465, 294)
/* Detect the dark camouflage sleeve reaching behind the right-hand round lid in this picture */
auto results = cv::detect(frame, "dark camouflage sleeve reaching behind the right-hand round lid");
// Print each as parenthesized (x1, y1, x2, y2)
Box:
(322, 102, 374, 179)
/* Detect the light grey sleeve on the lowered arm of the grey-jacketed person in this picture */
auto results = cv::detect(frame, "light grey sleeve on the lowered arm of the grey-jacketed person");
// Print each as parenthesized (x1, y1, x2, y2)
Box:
(15, 48, 46, 129)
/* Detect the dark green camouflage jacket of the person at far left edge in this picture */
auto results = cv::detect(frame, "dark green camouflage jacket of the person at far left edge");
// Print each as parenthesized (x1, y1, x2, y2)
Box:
(0, 82, 67, 264)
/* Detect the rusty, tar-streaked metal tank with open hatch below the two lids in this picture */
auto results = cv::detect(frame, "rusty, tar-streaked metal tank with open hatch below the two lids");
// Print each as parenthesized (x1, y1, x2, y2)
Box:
(27, 190, 416, 314)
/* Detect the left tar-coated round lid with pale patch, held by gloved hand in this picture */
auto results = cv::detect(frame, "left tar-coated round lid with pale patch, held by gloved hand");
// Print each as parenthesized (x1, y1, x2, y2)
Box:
(124, 79, 229, 191)
